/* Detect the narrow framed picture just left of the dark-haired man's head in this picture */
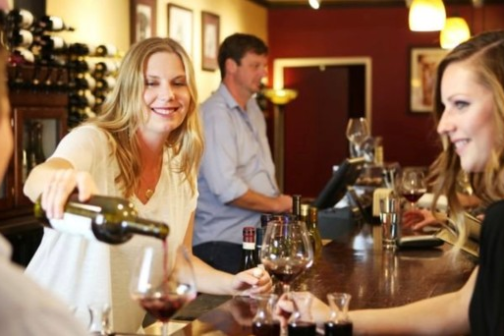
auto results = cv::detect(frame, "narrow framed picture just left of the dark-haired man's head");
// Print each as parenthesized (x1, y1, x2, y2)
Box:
(201, 11, 220, 71)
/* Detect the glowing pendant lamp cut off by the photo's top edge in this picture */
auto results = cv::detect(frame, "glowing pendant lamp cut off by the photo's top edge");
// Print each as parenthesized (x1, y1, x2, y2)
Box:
(409, 0, 446, 32)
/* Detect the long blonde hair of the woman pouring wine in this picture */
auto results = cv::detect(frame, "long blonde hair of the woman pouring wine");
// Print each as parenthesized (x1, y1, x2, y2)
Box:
(85, 37, 203, 198)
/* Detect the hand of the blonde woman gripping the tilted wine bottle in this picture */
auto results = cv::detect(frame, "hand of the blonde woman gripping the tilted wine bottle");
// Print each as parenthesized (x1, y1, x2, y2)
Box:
(42, 169, 98, 218)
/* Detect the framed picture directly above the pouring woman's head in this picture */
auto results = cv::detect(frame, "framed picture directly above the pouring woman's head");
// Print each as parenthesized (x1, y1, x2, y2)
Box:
(130, 0, 156, 44)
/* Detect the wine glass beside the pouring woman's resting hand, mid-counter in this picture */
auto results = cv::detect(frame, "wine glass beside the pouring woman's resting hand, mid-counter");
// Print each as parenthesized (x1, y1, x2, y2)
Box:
(261, 221, 313, 293)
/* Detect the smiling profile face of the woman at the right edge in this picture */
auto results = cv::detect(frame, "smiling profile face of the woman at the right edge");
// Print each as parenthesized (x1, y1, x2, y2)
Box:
(438, 62, 496, 172)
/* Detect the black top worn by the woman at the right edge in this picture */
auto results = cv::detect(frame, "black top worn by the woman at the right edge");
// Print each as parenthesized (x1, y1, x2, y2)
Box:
(469, 201, 504, 335)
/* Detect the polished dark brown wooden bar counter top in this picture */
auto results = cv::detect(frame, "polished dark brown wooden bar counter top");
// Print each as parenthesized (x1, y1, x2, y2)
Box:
(162, 225, 476, 335)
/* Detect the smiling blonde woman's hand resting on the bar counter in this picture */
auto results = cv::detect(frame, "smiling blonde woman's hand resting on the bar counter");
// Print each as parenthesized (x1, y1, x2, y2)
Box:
(231, 267, 273, 295)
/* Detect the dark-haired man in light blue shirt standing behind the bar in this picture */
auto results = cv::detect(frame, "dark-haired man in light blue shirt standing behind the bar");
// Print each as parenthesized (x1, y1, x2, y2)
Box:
(193, 34, 292, 273)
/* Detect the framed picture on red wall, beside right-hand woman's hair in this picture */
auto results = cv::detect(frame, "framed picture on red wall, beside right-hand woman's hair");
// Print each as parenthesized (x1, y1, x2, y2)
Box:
(410, 47, 447, 113)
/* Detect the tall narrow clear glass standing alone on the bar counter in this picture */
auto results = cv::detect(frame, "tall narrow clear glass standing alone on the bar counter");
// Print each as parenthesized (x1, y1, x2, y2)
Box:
(380, 195, 401, 250)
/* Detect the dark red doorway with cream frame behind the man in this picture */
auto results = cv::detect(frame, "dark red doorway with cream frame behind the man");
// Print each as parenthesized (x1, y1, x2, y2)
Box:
(274, 58, 371, 198)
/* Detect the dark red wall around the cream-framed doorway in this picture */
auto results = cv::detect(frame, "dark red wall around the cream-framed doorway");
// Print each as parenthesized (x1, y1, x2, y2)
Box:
(268, 3, 504, 166)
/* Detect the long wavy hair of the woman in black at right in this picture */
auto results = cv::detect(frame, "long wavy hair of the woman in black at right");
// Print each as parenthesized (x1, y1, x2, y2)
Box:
(430, 31, 504, 247)
